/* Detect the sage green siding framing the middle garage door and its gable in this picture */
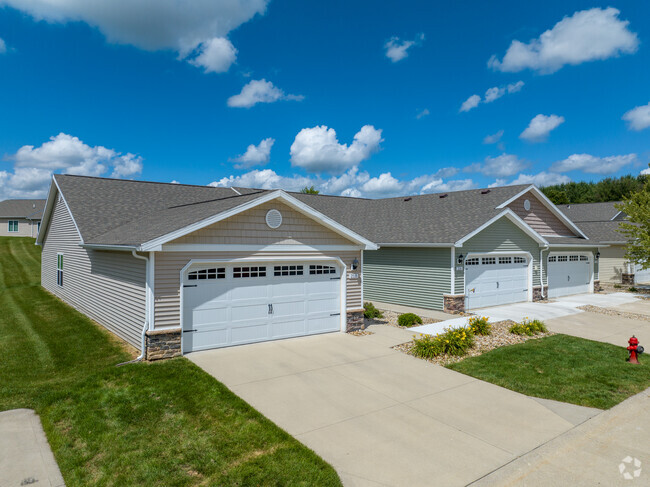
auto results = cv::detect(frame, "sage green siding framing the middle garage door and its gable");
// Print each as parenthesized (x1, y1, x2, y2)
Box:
(456, 217, 540, 294)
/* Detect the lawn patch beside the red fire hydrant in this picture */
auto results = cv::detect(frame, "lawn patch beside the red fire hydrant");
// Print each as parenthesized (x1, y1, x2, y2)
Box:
(448, 335, 650, 409)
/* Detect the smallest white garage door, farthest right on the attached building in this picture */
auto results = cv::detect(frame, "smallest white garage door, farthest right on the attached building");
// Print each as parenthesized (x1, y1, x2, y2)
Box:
(548, 254, 591, 298)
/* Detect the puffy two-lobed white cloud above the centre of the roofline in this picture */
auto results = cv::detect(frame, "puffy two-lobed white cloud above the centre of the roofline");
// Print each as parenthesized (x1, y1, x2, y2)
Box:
(290, 125, 384, 173)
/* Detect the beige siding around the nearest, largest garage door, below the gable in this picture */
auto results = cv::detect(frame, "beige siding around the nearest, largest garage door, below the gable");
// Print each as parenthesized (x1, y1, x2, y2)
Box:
(154, 251, 362, 328)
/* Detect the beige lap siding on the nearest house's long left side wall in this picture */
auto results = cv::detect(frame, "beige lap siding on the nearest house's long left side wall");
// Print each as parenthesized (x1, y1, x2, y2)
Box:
(41, 191, 146, 347)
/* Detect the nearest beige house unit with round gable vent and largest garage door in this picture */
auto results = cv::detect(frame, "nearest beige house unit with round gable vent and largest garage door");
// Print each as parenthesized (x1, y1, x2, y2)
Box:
(37, 175, 377, 359)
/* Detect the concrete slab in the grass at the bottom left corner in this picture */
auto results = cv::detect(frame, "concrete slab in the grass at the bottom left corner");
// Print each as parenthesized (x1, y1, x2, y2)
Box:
(0, 409, 65, 487)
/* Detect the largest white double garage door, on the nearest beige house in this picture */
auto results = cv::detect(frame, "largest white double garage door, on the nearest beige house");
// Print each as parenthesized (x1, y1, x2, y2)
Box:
(183, 262, 341, 352)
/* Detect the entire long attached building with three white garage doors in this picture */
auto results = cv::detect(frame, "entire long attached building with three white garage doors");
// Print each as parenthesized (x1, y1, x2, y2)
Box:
(37, 175, 603, 359)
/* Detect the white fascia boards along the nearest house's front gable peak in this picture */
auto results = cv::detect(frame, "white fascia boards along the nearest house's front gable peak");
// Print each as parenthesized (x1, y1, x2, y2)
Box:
(140, 190, 379, 251)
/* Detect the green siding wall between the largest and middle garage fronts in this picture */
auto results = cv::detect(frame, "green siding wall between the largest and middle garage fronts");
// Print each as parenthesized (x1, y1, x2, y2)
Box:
(363, 247, 451, 309)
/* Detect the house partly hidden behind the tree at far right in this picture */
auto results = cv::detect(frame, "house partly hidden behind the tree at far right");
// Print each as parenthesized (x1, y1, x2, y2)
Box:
(560, 201, 650, 285)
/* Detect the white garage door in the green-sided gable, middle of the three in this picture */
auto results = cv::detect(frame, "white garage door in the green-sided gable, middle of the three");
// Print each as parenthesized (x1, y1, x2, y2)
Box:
(465, 255, 528, 309)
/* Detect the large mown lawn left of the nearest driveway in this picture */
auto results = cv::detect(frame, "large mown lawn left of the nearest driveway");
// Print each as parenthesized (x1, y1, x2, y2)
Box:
(0, 237, 341, 487)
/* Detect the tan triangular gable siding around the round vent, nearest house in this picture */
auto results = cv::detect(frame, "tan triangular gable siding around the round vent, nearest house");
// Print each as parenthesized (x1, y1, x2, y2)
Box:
(171, 201, 353, 245)
